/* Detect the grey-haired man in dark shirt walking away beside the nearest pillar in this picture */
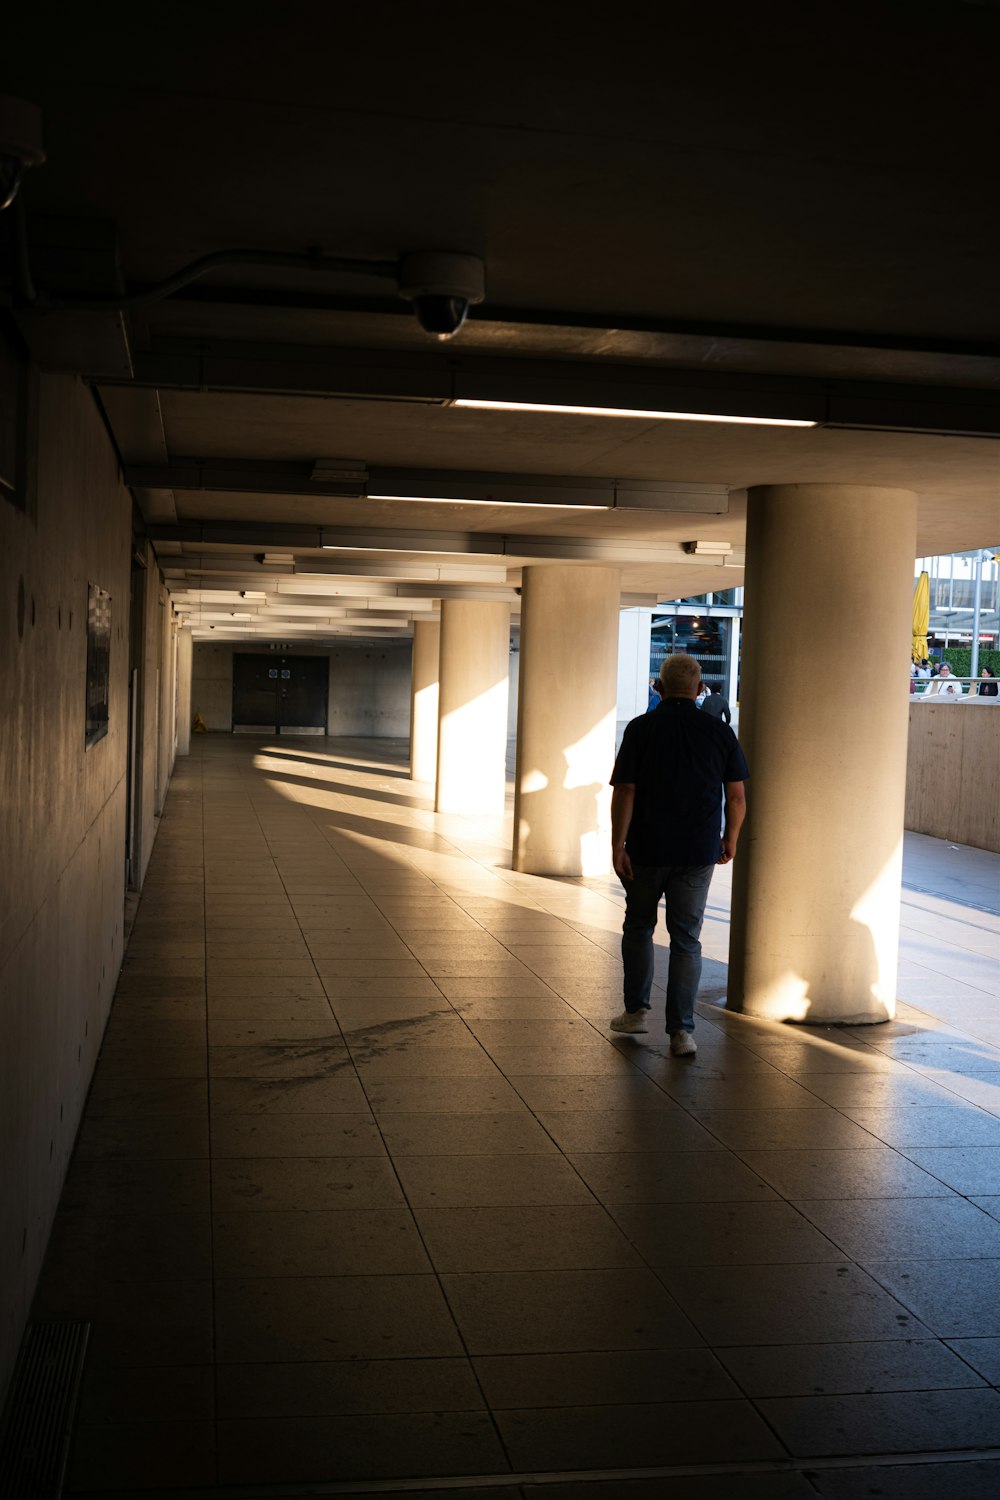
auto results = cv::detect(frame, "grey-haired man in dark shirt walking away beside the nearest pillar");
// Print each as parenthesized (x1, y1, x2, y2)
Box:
(610, 653, 750, 1058)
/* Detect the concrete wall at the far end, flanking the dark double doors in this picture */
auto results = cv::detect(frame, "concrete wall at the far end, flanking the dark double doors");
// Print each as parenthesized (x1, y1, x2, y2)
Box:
(190, 641, 411, 740)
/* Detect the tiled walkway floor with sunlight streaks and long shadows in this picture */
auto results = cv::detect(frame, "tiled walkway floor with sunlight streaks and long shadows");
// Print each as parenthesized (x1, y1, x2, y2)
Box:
(36, 738, 1000, 1500)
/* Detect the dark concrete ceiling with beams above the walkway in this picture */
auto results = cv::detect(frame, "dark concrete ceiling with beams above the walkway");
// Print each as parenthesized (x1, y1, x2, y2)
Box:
(0, 0, 1000, 636)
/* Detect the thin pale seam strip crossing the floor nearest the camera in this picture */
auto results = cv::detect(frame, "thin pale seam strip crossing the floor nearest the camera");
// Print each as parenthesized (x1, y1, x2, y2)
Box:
(76, 1448, 1000, 1500)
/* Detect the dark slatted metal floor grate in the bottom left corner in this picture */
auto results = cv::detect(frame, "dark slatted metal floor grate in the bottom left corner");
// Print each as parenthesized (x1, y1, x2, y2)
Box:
(0, 1322, 90, 1500)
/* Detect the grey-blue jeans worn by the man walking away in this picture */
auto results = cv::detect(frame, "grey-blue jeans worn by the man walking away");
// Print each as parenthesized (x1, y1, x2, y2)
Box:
(622, 864, 715, 1034)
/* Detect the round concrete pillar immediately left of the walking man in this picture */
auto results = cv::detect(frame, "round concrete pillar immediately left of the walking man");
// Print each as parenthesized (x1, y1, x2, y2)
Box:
(514, 566, 617, 875)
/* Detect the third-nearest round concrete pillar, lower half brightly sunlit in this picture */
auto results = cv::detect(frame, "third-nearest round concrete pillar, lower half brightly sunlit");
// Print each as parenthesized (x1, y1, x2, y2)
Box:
(435, 599, 510, 813)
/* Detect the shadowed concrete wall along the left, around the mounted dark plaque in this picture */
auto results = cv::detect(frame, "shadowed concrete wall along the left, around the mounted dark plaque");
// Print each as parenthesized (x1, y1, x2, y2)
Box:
(0, 375, 132, 1395)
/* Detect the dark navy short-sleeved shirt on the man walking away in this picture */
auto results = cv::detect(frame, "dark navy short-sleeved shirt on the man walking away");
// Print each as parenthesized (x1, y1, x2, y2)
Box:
(612, 698, 750, 864)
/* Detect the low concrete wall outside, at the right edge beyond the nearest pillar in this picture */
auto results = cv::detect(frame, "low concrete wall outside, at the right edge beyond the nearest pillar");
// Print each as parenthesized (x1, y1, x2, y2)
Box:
(906, 698, 1000, 854)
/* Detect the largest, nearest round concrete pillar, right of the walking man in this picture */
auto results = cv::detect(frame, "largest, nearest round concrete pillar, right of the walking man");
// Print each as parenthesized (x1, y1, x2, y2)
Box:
(727, 485, 916, 1025)
